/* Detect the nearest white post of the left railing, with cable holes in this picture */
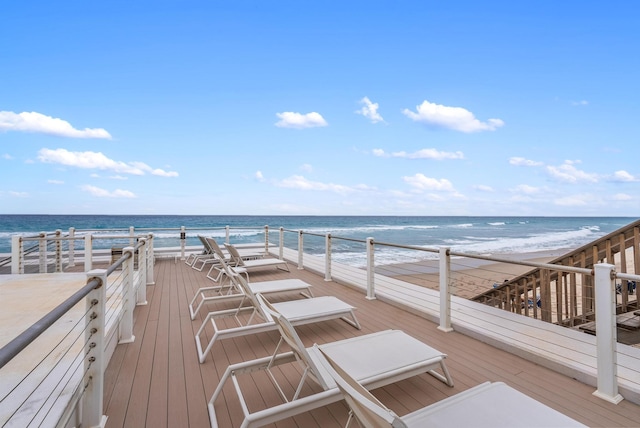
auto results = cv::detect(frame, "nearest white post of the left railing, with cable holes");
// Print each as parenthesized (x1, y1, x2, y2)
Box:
(81, 269, 107, 427)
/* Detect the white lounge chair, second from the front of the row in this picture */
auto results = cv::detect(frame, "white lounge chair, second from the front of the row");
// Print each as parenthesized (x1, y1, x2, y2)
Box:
(208, 295, 453, 428)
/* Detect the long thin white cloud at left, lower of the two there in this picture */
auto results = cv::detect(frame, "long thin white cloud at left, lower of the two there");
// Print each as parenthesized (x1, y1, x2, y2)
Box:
(38, 149, 178, 177)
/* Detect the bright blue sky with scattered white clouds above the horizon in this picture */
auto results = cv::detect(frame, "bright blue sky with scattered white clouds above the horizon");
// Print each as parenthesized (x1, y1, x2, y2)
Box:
(0, 0, 640, 217)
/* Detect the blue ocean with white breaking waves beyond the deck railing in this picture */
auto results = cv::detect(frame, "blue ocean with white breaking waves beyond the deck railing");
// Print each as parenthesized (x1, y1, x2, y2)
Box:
(0, 215, 637, 266)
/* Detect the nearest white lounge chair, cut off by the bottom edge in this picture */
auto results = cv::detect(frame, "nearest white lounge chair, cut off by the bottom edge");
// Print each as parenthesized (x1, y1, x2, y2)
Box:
(314, 345, 584, 428)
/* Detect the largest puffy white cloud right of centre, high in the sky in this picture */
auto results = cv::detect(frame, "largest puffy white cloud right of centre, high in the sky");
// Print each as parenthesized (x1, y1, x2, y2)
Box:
(402, 100, 504, 133)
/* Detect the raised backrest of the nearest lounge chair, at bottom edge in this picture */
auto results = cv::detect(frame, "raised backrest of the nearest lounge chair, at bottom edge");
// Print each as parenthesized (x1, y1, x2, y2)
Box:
(313, 344, 407, 428)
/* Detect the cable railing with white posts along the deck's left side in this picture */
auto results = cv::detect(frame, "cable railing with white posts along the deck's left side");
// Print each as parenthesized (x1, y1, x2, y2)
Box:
(0, 236, 153, 426)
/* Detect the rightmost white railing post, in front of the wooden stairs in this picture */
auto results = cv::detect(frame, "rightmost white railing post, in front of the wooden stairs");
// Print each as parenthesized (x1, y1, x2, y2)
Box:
(593, 263, 623, 404)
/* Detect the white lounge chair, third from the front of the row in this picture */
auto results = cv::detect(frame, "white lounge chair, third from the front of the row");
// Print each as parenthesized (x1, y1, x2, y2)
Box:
(195, 265, 360, 363)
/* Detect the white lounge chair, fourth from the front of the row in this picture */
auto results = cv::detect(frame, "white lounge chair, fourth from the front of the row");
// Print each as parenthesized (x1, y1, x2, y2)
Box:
(189, 254, 313, 320)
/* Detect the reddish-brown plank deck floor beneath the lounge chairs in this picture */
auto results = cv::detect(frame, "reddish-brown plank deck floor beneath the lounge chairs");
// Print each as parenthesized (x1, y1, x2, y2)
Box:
(104, 259, 640, 427)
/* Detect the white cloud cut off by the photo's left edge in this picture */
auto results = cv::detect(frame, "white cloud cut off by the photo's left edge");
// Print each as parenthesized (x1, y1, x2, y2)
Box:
(0, 111, 111, 139)
